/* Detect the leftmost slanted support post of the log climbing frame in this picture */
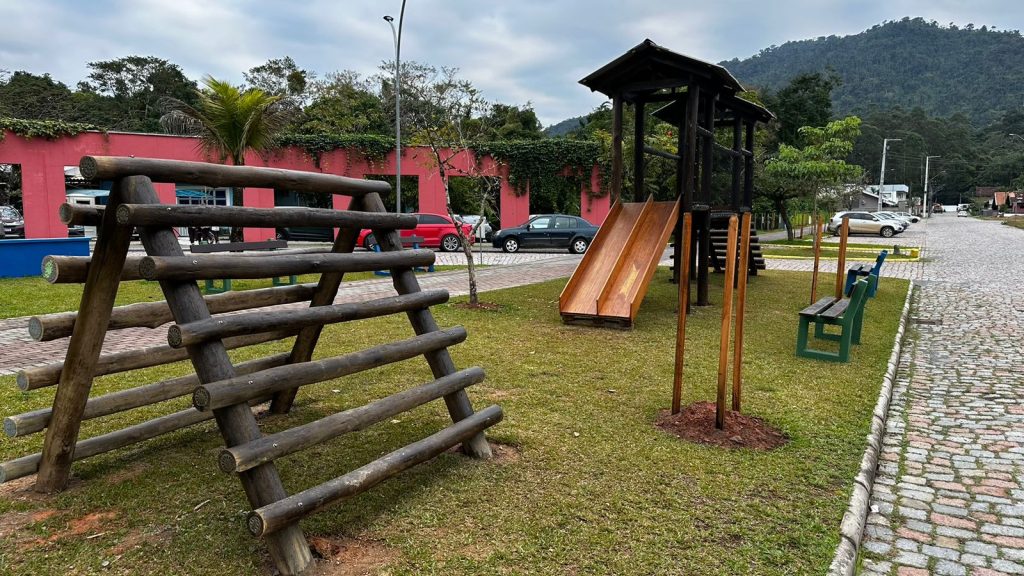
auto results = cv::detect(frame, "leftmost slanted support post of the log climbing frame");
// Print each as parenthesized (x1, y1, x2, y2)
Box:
(36, 178, 138, 493)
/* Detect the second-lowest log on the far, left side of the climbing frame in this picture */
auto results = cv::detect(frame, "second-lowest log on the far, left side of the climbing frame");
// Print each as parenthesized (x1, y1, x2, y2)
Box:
(3, 353, 289, 438)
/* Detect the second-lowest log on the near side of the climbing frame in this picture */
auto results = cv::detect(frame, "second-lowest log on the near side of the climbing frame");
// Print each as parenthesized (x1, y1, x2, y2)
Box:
(217, 368, 483, 472)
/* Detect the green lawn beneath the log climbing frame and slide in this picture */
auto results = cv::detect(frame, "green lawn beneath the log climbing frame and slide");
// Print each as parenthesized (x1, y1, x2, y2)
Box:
(0, 270, 907, 575)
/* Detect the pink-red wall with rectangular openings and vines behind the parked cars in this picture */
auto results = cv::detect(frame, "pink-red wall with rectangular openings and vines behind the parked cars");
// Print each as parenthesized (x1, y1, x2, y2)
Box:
(0, 131, 609, 241)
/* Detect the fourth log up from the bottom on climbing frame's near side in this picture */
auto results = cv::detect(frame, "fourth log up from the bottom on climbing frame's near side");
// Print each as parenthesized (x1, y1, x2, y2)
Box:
(167, 290, 449, 348)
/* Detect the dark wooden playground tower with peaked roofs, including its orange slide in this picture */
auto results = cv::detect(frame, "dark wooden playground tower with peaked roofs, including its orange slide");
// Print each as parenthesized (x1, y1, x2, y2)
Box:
(559, 40, 774, 327)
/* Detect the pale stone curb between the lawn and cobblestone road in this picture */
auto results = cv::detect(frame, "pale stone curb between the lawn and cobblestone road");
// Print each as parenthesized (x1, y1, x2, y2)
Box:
(828, 280, 914, 576)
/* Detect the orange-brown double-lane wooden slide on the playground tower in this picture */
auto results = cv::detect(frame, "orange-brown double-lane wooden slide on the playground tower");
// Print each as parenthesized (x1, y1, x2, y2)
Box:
(558, 197, 679, 328)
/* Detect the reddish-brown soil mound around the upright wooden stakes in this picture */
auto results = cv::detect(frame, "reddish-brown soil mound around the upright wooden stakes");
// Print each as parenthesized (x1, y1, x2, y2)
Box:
(654, 402, 788, 450)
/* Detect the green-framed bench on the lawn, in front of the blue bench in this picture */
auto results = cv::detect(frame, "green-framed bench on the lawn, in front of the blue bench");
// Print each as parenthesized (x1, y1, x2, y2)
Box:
(797, 277, 872, 362)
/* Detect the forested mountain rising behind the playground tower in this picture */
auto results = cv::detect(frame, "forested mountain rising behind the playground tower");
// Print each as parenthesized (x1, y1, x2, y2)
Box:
(722, 17, 1024, 126)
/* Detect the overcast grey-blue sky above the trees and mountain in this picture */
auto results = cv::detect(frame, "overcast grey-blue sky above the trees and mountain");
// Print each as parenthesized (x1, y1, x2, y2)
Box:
(6, 0, 1024, 125)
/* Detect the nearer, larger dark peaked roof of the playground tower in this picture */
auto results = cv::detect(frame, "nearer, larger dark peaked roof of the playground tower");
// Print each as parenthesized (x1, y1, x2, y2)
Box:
(580, 39, 743, 100)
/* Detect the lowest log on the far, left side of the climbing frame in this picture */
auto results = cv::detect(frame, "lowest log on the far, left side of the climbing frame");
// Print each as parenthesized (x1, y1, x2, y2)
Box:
(0, 398, 269, 484)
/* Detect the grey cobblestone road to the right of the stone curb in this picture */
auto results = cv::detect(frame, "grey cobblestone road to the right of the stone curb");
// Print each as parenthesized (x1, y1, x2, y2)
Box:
(860, 215, 1024, 576)
